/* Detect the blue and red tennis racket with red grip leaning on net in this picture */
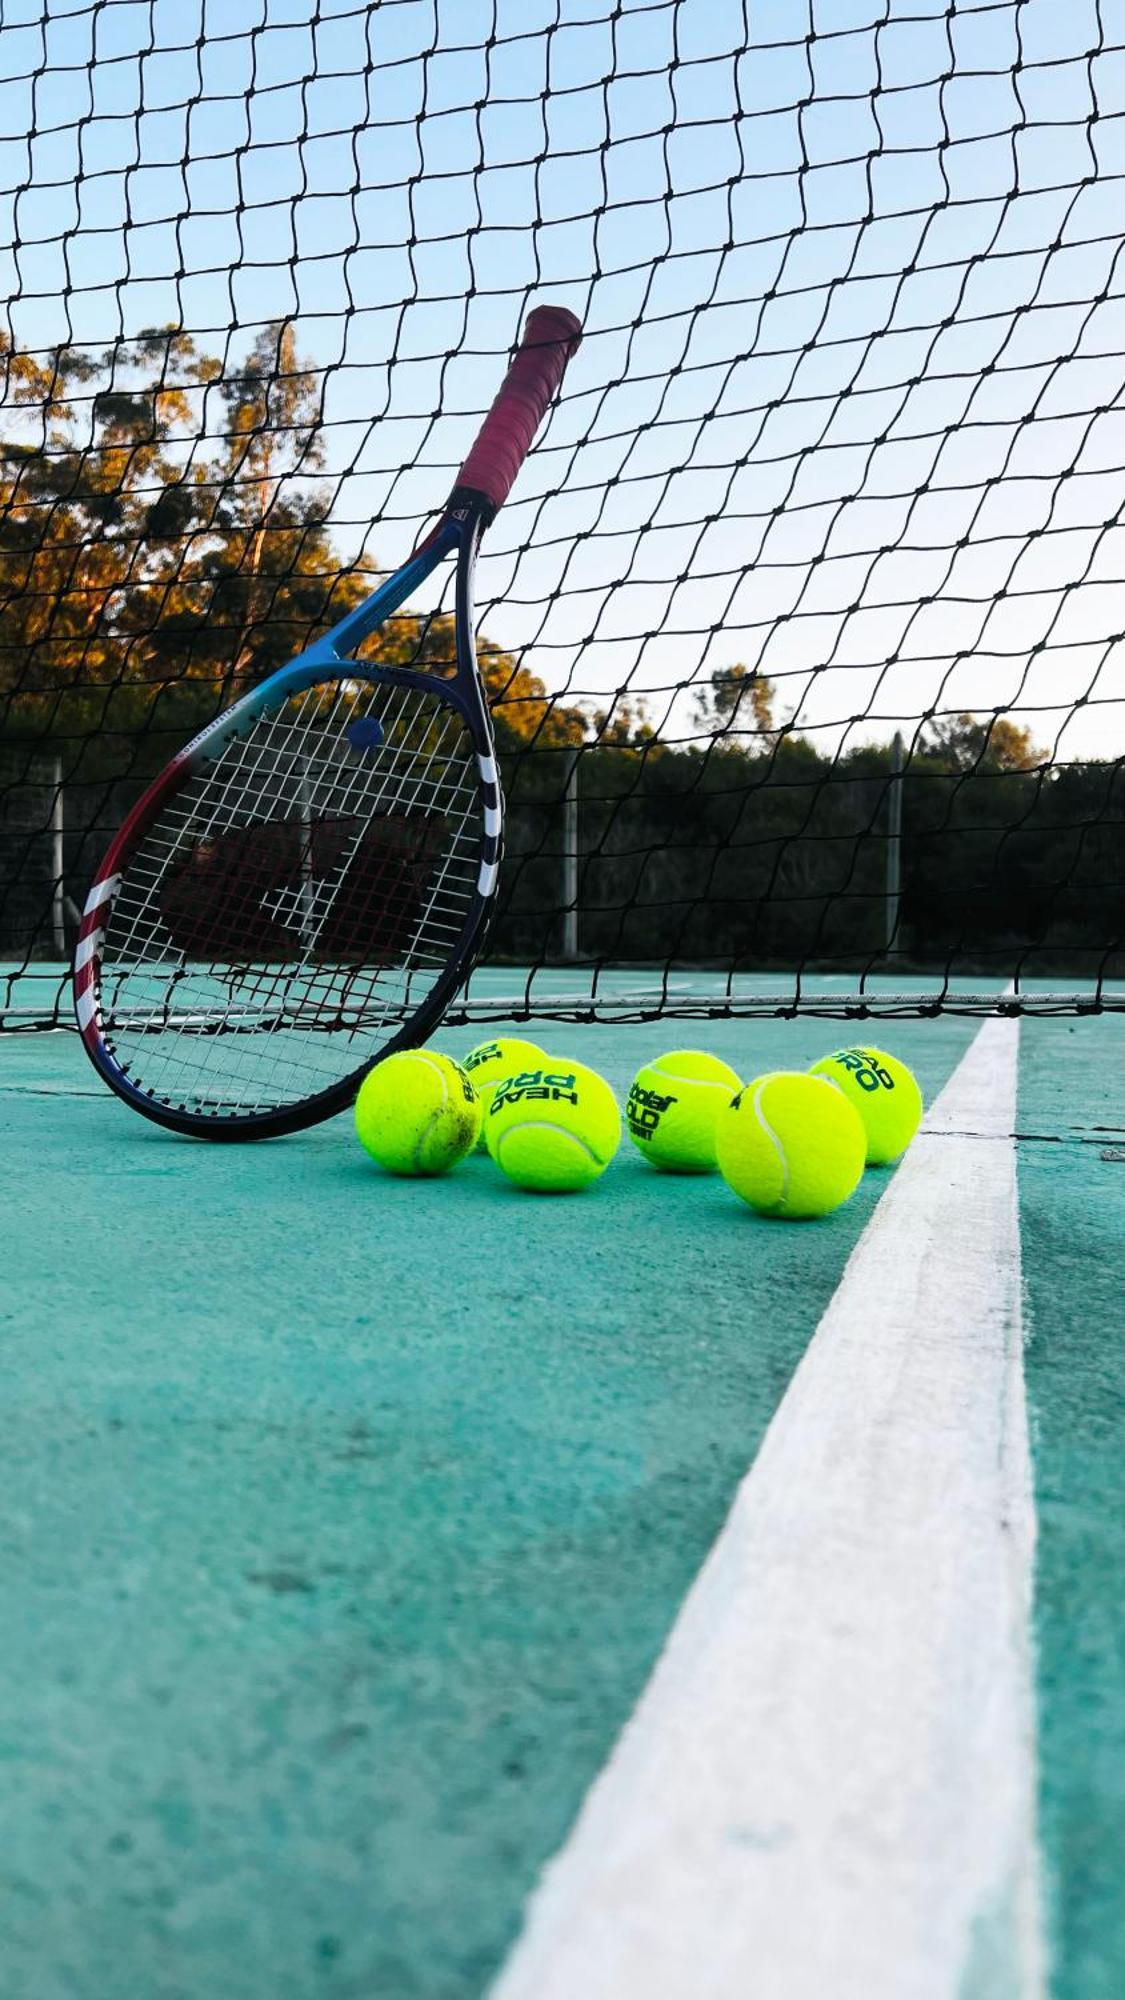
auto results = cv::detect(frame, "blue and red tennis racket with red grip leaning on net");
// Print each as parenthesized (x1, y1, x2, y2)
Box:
(74, 306, 581, 1138)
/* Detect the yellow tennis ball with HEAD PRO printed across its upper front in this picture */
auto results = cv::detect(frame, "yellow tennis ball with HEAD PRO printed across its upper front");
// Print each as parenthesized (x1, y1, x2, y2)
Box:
(484, 1056, 621, 1194)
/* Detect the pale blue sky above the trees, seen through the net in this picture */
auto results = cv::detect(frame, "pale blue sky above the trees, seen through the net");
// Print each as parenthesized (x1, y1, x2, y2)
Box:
(0, 0, 1125, 760)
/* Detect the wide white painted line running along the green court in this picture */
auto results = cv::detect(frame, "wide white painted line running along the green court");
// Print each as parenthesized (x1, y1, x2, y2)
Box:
(494, 1020, 1047, 2000)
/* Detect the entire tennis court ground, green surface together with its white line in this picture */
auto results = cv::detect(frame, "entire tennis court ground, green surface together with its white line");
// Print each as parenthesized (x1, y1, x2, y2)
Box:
(0, 972, 1125, 2000)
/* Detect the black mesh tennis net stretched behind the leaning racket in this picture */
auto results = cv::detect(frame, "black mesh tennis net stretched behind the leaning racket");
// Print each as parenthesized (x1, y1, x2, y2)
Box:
(0, 0, 1125, 1026)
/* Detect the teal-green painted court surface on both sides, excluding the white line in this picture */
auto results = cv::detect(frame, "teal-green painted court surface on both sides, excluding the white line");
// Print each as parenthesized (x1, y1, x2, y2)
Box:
(0, 1000, 1125, 2000)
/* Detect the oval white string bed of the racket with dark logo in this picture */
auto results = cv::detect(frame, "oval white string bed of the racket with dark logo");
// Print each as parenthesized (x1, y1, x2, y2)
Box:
(102, 680, 482, 1114)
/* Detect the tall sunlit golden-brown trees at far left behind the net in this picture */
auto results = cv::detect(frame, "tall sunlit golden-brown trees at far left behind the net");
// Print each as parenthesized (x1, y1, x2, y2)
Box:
(0, 324, 366, 768)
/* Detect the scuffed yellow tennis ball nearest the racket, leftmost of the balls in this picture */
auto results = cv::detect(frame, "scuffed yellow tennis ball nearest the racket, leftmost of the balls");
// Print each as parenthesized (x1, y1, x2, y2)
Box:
(356, 1048, 480, 1174)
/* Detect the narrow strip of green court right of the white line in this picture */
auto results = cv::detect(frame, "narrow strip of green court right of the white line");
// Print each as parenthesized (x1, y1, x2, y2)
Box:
(1019, 1018, 1125, 2000)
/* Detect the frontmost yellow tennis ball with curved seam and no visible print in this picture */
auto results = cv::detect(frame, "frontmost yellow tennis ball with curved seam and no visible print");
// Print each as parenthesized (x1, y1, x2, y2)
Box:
(715, 1070, 867, 1218)
